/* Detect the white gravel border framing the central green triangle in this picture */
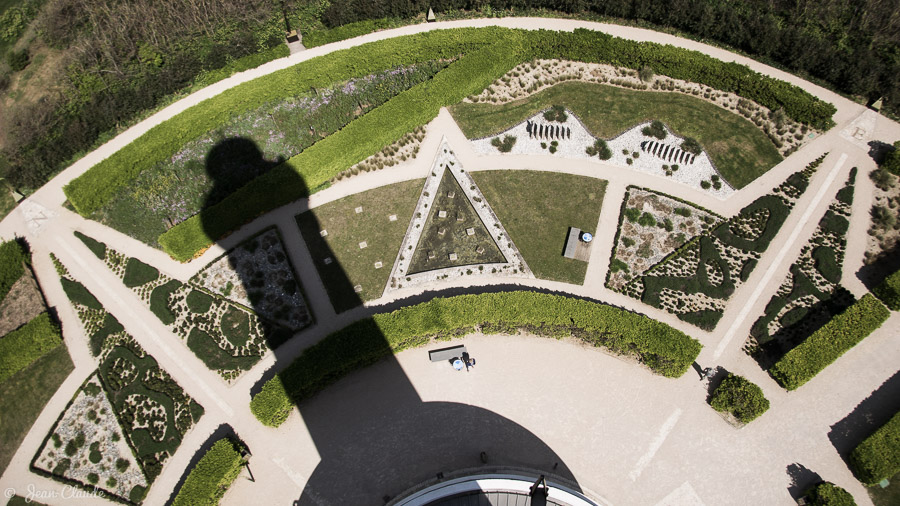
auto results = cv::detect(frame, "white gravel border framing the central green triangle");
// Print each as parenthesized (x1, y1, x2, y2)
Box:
(384, 137, 534, 293)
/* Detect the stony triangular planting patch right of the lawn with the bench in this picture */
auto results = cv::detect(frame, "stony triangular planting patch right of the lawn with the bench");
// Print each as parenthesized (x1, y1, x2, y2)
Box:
(606, 186, 722, 291)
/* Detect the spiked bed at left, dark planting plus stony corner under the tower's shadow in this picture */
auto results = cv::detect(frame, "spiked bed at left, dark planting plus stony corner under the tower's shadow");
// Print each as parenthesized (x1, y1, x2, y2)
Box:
(79, 233, 298, 381)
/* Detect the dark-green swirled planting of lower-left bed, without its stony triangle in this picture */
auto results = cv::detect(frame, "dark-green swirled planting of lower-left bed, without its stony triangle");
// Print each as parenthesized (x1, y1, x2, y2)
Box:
(54, 258, 203, 490)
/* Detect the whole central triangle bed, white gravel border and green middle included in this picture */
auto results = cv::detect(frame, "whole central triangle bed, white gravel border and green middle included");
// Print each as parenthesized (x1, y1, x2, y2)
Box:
(385, 137, 534, 293)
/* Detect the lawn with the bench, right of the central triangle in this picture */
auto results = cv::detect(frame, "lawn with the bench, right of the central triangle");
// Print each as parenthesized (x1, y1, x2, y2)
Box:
(471, 170, 615, 285)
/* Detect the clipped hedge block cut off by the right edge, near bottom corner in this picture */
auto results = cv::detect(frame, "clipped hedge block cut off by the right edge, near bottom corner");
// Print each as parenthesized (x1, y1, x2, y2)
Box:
(850, 413, 900, 485)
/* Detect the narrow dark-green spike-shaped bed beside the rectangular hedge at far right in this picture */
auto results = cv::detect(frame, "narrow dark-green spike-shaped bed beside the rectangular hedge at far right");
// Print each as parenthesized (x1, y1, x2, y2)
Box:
(745, 168, 856, 368)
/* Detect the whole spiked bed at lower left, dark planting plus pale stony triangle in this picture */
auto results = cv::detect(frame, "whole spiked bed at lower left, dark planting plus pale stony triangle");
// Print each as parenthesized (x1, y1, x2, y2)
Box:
(44, 257, 204, 502)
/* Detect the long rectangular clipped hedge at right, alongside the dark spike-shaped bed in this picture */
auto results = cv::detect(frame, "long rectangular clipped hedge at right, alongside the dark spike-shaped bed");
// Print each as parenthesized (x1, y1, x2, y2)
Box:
(771, 293, 891, 390)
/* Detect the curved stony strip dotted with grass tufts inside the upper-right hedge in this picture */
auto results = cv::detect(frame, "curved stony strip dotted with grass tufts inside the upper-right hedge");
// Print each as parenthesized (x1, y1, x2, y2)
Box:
(466, 60, 820, 156)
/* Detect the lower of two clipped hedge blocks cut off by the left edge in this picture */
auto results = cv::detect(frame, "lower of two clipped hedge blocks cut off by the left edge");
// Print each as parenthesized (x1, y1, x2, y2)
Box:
(0, 313, 62, 383)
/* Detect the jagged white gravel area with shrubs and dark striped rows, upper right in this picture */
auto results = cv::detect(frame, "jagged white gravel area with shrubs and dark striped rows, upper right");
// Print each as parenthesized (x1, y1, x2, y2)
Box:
(471, 109, 735, 200)
